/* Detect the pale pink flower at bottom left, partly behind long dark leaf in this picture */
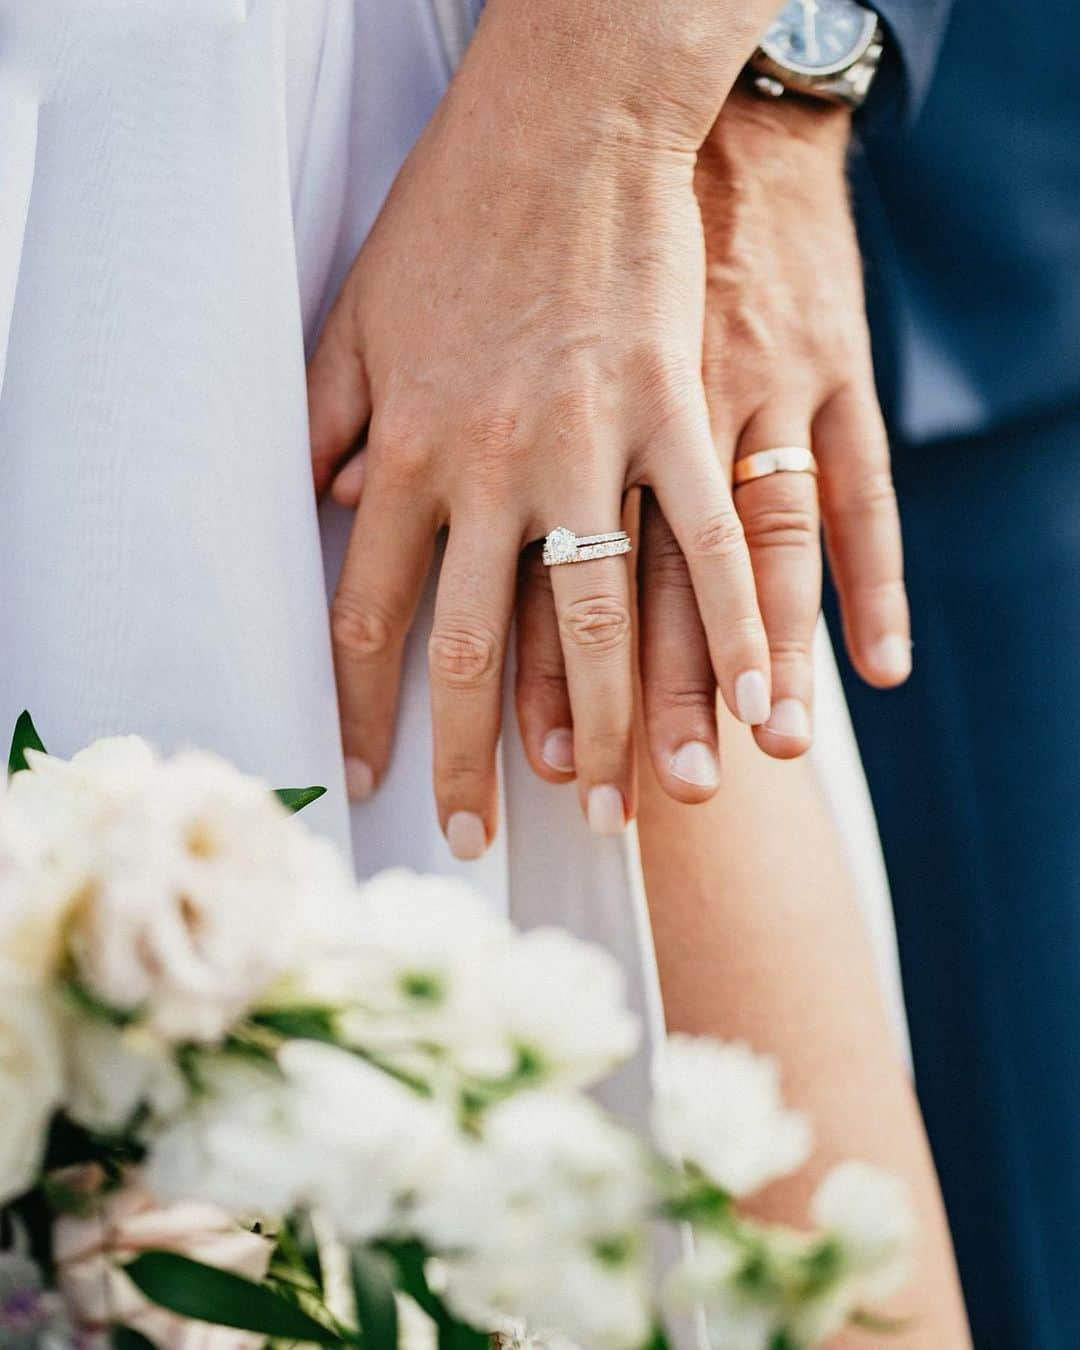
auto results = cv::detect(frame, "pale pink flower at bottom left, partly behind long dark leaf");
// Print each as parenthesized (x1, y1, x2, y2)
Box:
(53, 1180, 274, 1350)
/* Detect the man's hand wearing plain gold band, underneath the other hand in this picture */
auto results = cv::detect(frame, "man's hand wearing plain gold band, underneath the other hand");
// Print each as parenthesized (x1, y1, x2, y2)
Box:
(518, 90, 910, 802)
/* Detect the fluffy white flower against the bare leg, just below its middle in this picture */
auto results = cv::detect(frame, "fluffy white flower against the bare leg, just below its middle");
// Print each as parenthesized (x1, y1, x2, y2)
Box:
(653, 1035, 810, 1196)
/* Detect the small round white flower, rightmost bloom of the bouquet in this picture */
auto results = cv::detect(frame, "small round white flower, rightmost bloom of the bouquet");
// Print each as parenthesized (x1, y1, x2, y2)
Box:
(810, 1161, 915, 1300)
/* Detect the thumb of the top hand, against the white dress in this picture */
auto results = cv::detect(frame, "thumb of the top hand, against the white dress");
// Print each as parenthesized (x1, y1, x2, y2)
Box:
(308, 302, 371, 497)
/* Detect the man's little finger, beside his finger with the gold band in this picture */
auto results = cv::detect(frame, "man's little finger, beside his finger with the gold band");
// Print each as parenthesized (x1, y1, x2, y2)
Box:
(814, 387, 911, 689)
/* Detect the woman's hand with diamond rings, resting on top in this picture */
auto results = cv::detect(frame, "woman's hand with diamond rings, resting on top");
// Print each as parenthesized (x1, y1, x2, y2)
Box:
(309, 0, 771, 857)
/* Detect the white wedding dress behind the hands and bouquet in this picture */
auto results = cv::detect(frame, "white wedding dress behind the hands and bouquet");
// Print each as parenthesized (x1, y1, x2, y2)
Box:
(0, 0, 899, 1112)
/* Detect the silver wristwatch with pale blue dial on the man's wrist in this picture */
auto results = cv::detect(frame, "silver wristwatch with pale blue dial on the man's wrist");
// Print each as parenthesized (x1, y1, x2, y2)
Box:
(748, 0, 884, 108)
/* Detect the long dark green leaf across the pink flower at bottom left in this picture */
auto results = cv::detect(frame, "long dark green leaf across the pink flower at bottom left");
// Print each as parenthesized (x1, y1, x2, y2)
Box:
(124, 1251, 348, 1346)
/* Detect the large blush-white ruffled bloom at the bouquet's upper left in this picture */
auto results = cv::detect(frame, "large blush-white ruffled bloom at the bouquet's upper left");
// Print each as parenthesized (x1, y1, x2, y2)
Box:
(8, 737, 351, 1044)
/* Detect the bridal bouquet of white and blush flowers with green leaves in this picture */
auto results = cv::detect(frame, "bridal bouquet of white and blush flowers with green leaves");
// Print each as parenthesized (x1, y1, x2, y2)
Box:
(0, 716, 911, 1350)
